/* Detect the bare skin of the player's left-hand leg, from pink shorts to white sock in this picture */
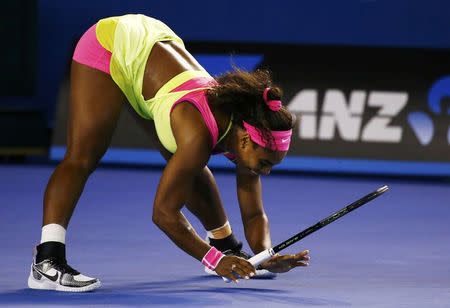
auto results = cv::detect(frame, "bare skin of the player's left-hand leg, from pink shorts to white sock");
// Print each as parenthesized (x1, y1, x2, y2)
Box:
(43, 61, 125, 228)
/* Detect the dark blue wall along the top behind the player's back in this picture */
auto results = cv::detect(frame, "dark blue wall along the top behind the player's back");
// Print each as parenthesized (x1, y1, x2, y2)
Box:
(28, 0, 450, 127)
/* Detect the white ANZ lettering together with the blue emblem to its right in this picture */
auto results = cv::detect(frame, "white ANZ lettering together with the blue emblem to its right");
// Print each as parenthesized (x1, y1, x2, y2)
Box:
(288, 76, 450, 145)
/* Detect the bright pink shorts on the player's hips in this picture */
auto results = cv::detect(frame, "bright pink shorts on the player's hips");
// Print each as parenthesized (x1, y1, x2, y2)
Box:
(72, 25, 111, 75)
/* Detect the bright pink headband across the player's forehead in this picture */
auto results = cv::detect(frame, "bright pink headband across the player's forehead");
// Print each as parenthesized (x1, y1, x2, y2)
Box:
(242, 121, 292, 151)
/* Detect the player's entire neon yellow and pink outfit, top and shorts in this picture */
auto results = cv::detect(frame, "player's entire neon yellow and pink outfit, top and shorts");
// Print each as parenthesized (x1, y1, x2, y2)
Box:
(73, 15, 231, 153)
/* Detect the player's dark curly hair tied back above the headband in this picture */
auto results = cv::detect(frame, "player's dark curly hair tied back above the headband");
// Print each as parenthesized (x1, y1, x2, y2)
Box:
(206, 69, 295, 148)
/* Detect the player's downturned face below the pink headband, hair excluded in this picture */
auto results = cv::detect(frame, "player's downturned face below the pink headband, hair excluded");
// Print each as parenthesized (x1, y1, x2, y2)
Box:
(234, 130, 287, 175)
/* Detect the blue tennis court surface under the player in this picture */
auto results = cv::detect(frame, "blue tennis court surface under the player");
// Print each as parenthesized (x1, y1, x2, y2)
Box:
(0, 165, 450, 308)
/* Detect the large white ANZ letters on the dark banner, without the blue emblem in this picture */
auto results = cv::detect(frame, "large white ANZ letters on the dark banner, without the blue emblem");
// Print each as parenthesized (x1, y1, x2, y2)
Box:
(288, 89, 408, 142)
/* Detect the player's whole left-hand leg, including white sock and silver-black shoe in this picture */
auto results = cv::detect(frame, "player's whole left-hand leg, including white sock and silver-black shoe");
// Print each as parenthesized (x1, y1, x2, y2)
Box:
(28, 61, 124, 292)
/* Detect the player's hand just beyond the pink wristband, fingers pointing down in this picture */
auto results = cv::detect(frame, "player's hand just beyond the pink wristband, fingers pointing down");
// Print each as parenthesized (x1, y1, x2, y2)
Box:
(215, 256, 256, 283)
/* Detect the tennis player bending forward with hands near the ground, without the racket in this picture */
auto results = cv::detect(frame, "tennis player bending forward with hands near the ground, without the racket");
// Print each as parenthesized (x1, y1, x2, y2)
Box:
(28, 15, 309, 292)
